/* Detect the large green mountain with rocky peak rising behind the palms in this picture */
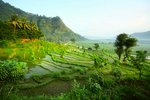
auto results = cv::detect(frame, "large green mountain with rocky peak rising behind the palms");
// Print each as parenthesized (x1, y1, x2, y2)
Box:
(0, 0, 86, 41)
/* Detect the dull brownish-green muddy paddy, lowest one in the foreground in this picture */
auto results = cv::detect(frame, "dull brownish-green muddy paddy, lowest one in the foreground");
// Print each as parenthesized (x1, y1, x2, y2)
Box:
(20, 80, 73, 96)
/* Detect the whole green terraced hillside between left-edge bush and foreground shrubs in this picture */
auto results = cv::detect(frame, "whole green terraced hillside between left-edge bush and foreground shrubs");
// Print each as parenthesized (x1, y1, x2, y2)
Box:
(0, 41, 150, 100)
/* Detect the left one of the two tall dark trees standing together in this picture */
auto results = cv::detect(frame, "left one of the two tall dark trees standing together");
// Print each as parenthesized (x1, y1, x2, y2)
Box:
(114, 33, 128, 60)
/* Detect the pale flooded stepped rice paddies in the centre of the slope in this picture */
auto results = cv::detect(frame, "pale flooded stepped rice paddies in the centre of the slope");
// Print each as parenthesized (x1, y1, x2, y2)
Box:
(26, 52, 94, 78)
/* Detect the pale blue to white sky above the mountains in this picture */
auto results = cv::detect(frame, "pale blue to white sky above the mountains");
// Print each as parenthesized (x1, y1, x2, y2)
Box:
(3, 0, 150, 39)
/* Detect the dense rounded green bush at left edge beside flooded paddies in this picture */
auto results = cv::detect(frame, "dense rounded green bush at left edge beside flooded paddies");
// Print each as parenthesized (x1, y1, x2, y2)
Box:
(0, 60, 27, 82)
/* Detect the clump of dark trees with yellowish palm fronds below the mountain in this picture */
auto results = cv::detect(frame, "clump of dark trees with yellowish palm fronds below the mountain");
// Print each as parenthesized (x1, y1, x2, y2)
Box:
(0, 14, 43, 40)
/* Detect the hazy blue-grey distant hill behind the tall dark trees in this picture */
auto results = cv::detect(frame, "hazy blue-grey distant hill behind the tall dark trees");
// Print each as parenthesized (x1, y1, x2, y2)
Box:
(131, 31, 150, 40)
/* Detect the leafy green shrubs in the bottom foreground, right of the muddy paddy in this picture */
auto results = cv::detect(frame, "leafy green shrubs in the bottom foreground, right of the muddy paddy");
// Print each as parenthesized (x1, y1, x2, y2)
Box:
(66, 73, 116, 100)
